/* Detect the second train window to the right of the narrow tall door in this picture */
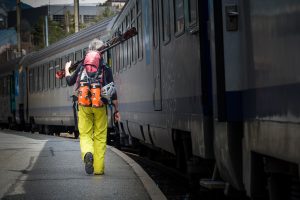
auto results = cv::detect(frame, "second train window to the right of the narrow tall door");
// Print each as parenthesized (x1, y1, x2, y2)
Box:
(174, 0, 184, 36)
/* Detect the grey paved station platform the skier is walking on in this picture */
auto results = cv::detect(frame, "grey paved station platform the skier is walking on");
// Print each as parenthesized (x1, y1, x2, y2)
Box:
(0, 130, 166, 200)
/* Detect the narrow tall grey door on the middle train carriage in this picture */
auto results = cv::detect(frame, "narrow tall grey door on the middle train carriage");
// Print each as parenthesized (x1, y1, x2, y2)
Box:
(152, 0, 162, 111)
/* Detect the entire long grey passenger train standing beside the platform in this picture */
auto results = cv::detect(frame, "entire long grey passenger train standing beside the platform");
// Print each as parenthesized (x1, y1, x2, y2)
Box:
(0, 0, 300, 200)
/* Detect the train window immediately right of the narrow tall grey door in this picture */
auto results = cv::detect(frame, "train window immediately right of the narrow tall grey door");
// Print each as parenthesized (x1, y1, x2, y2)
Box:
(162, 0, 171, 44)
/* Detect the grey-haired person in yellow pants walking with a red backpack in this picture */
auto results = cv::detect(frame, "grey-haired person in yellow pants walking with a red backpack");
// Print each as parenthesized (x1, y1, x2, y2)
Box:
(65, 39, 120, 175)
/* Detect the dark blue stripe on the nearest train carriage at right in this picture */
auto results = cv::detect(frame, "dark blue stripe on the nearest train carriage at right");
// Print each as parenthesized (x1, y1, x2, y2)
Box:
(226, 83, 300, 121)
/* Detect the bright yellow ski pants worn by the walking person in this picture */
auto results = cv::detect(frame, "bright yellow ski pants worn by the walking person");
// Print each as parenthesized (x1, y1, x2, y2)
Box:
(78, 106, 107, 174)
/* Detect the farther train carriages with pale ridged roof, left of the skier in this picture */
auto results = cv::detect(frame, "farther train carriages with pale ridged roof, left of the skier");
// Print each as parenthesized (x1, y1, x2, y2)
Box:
(0, 18, 112, 138)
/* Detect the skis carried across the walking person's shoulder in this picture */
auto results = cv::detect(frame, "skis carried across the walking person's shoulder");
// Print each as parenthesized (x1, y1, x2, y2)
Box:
(55, 27, 138, 79)
